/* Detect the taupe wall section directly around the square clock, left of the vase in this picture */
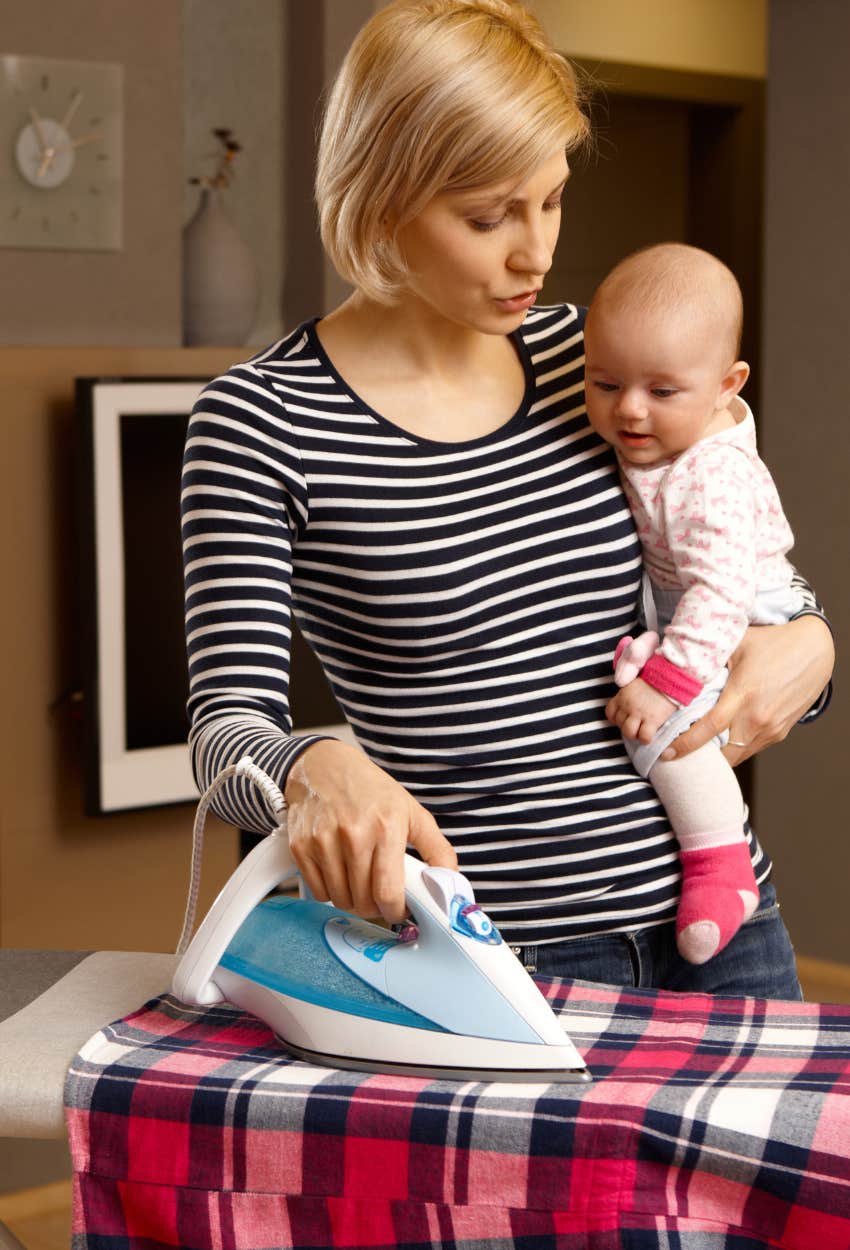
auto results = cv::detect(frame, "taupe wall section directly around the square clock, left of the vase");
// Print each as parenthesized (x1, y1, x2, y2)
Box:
(0, 0, 183, 346)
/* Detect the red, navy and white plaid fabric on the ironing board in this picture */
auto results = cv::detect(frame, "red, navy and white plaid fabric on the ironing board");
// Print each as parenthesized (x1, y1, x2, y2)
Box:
(65, 981, 850, 1250)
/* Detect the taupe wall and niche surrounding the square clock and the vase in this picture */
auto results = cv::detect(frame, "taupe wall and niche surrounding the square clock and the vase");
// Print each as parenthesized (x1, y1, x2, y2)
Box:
(0, 0, 292, 345)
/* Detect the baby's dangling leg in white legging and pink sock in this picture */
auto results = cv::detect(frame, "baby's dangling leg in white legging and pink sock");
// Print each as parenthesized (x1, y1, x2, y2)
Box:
(649, 743, 759, 964)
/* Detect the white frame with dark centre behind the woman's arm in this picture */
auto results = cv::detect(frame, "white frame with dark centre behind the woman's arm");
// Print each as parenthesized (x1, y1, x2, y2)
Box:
(76, 378, 354, 815)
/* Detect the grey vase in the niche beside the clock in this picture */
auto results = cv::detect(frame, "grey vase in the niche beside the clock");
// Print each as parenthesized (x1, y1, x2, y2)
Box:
(183, 189, 259, 348)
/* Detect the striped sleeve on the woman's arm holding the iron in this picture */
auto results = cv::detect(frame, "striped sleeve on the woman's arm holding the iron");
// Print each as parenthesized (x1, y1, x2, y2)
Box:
(181, 365, 330, 831)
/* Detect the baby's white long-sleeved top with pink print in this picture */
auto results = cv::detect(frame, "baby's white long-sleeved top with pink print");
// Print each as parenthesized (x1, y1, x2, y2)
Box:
(620, 399, 794, 703)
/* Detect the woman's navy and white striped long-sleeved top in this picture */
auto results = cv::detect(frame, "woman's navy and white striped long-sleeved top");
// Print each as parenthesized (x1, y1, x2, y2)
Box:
(183, 305, 770, 943)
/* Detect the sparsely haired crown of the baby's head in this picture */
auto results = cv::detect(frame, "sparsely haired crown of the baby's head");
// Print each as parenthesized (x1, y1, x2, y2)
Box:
(588, 243, 744, 363)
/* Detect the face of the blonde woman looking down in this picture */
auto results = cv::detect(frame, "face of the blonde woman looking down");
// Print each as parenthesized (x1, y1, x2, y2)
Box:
(399, 151, 569, 334)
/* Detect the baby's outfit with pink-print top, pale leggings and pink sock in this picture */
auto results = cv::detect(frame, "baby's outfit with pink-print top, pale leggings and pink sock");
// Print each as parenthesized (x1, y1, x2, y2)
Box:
(615, 399, 803, 964)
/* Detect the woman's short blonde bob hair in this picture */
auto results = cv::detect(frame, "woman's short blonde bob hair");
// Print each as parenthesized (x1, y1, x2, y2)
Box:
(316, 0, 589, 304)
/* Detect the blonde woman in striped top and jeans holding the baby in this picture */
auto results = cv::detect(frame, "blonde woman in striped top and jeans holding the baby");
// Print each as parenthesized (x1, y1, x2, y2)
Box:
(184, 0, 831, 996)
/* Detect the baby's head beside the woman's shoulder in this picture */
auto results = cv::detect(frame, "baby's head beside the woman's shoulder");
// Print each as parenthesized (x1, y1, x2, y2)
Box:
(585, 243, 750, 465)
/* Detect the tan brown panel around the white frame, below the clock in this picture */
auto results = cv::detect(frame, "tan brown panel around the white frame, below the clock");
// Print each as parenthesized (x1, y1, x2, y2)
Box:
(0, 348, 245, 951)
